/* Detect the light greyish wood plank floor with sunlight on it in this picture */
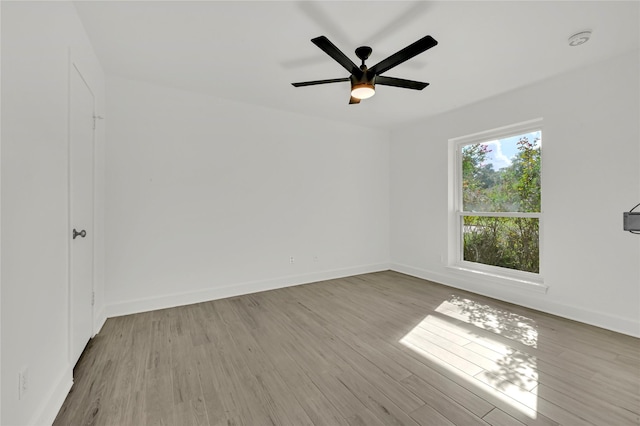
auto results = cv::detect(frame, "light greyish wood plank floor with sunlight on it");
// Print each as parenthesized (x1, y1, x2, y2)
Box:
(55, 272, 640, 426)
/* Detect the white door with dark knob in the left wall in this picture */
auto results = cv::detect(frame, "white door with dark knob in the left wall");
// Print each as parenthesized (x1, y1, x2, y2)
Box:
(69, 64, 95, 365)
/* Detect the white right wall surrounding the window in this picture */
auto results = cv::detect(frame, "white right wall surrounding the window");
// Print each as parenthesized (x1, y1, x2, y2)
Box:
(391, 52, 640, 336)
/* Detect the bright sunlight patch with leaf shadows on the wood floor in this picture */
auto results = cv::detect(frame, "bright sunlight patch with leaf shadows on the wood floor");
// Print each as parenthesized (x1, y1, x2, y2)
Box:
(400, 296, 538, 418)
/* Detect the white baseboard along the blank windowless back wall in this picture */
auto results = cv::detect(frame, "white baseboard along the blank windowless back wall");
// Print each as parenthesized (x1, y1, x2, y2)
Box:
(104, 263, 389, 318)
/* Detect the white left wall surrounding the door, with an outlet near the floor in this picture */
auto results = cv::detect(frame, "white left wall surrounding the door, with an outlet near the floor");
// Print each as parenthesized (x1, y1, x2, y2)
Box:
(0, 2, 104, 425)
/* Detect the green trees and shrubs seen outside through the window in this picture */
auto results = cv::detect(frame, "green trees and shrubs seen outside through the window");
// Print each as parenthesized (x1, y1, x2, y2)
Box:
(462, 132, 541, 273)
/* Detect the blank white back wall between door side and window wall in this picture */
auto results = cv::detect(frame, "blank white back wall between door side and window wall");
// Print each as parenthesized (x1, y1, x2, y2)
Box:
(106, 77, 389, 316)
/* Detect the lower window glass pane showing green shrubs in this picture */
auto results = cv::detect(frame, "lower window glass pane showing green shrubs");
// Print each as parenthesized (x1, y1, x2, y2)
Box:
(463, 216, 540, 273)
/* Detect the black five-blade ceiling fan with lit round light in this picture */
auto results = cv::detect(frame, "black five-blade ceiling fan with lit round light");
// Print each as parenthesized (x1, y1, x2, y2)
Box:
(291, 35, 438, 104)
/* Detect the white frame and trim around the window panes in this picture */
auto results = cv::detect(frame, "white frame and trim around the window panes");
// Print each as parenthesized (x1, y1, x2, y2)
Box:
(448, 118, 546, 288)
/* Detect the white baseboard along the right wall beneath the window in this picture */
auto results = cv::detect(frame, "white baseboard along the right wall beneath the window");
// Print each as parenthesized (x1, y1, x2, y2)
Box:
(389, 263, 640, 337)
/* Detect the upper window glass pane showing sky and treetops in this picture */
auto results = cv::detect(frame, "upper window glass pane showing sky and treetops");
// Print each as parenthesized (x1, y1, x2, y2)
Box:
(462, 131, 542, 212)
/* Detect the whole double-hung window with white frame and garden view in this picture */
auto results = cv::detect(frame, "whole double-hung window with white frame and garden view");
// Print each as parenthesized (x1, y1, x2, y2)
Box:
(451, 120, 542, 281)
